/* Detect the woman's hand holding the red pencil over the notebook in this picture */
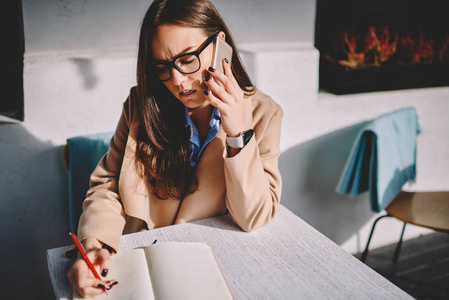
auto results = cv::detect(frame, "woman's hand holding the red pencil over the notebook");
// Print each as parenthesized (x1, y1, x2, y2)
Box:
(67, 237, 118, 298)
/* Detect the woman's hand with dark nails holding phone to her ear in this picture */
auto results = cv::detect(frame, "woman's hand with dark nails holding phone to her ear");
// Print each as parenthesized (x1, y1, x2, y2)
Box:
(205, 60, 251, 137)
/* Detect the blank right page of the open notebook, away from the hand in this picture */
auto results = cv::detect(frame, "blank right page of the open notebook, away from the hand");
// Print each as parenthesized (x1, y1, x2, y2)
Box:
(145, 243, 232, 300)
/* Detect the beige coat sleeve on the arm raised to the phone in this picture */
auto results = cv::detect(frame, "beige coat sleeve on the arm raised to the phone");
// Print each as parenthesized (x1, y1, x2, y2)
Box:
(224, 98, 283, 231)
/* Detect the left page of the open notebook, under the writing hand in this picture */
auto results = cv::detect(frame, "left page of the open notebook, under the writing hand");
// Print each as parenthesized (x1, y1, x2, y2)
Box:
(73, 249, 154, 300)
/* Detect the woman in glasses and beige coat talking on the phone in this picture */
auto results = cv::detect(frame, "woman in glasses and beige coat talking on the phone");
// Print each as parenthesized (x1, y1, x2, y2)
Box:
(68, 0, 283, 297)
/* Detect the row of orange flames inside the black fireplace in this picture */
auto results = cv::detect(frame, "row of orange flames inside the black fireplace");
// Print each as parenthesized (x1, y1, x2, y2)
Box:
(325, 25, 449, 68)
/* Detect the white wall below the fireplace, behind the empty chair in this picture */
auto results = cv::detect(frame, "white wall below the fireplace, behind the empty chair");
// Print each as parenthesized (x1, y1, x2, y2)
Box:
(243, 44, 449, 253)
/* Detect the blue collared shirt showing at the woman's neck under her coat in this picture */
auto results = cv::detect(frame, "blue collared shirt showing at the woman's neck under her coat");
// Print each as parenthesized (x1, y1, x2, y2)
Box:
(185, 107, 221, 167)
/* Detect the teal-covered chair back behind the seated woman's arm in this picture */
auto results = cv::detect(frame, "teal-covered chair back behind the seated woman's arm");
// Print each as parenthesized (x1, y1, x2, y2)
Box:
(63, 132, 113, 232)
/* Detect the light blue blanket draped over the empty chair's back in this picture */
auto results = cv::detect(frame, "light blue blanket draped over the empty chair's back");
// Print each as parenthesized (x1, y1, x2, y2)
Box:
(336, 107, 420, 212)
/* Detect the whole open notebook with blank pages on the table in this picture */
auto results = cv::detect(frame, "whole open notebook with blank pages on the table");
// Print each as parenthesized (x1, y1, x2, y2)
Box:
(73, 242, 233, 300)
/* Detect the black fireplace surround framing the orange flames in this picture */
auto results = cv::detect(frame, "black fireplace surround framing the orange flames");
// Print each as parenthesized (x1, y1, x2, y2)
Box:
(315, 0, 449, 95)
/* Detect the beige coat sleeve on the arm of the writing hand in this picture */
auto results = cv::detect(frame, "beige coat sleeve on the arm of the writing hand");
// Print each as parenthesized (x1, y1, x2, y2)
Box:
(78, 91, 132, 251)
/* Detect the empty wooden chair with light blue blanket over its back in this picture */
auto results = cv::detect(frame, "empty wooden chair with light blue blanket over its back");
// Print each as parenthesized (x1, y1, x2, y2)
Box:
(337, 107, 449, 261)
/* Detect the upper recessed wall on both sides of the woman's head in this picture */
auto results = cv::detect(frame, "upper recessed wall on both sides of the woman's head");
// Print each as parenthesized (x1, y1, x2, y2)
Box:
(23, 0, 315, 56)
